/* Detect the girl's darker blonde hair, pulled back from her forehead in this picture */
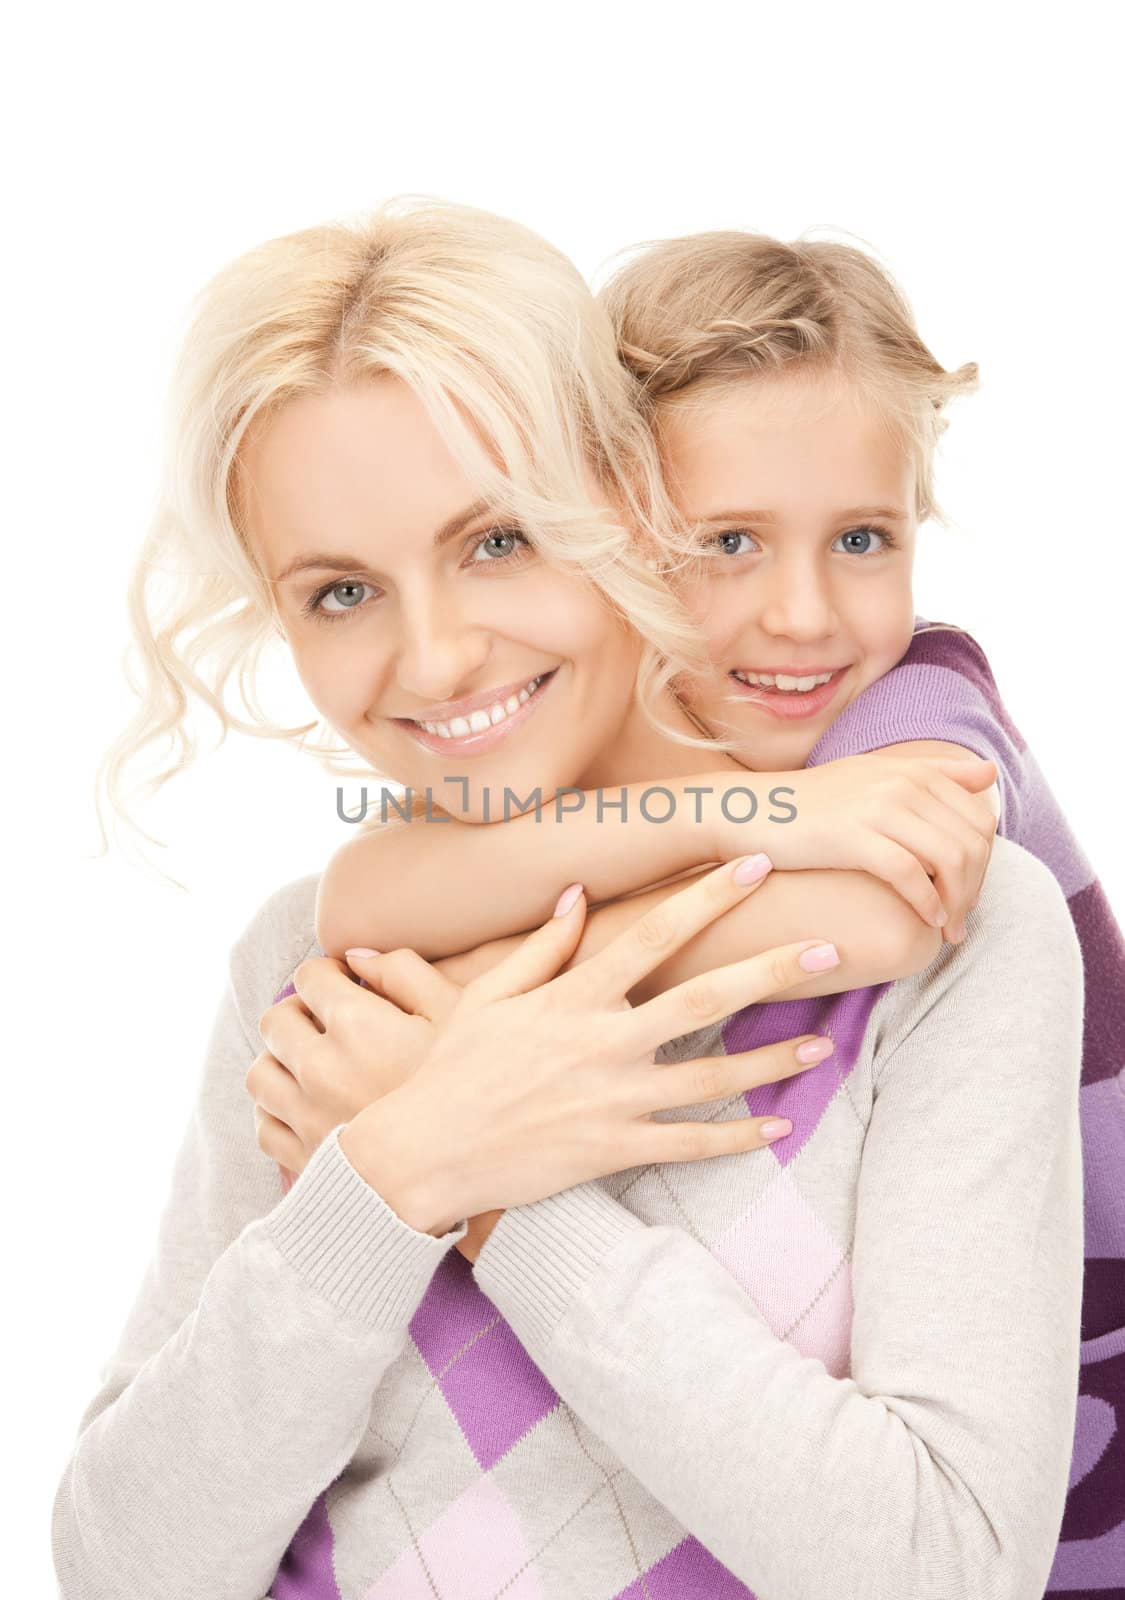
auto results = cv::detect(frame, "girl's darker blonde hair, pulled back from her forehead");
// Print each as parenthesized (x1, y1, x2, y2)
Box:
(599, 232, 978, 522)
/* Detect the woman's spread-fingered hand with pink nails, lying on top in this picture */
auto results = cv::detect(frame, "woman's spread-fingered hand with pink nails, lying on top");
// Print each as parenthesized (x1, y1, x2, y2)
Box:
(339, 858, 839, 1237)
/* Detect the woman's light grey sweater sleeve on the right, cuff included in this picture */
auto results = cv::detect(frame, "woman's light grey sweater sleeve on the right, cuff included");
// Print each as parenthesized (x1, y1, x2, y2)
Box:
(475, 843, 1082, 1600)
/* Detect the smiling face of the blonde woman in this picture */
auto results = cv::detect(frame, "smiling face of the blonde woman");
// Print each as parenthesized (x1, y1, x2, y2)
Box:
(242, 376, 640, 821)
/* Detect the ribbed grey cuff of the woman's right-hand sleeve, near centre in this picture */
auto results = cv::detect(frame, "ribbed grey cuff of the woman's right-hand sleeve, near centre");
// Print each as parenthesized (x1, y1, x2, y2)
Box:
(474, 1184, 645, 1360)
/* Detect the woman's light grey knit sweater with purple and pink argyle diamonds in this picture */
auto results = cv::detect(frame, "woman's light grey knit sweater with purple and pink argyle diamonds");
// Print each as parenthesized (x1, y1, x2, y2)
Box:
(53, 838, 1082, 1600)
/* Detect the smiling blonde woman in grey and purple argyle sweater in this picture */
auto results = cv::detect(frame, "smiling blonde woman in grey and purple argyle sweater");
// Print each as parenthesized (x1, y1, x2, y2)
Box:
(54, 208, 1080, 1600)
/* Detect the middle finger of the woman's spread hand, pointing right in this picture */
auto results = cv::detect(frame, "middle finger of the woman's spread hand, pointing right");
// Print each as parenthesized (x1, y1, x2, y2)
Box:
(630, 939, 840, 1050)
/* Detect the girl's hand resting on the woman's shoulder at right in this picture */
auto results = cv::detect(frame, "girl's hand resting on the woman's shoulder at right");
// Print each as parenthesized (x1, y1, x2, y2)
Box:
(706, 750, 997, 944)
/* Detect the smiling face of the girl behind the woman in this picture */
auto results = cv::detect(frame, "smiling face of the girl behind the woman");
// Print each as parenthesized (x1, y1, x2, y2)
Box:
(661, 373, 917, 771)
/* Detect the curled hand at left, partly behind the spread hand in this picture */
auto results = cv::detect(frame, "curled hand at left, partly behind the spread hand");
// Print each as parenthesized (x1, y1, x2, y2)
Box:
(246, 950, 502, 1261)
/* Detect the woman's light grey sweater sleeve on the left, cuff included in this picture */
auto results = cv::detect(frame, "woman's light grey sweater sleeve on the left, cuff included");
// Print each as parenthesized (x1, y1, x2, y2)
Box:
(51, 878, 466, 1600)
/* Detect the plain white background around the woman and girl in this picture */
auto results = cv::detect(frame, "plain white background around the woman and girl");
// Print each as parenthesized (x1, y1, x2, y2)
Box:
(13, 0, 1125, 1595)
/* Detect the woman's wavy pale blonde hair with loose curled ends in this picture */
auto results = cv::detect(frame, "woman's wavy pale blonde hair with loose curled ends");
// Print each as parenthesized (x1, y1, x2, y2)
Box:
(96, 197, 715, 883)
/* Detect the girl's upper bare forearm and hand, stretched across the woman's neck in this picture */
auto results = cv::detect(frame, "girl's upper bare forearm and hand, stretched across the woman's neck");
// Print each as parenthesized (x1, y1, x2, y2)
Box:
(317, 758, 992, 976)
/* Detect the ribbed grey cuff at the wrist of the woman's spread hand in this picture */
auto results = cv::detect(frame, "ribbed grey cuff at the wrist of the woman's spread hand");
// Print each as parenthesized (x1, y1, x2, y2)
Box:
(264, 1123, 469, 1328)
